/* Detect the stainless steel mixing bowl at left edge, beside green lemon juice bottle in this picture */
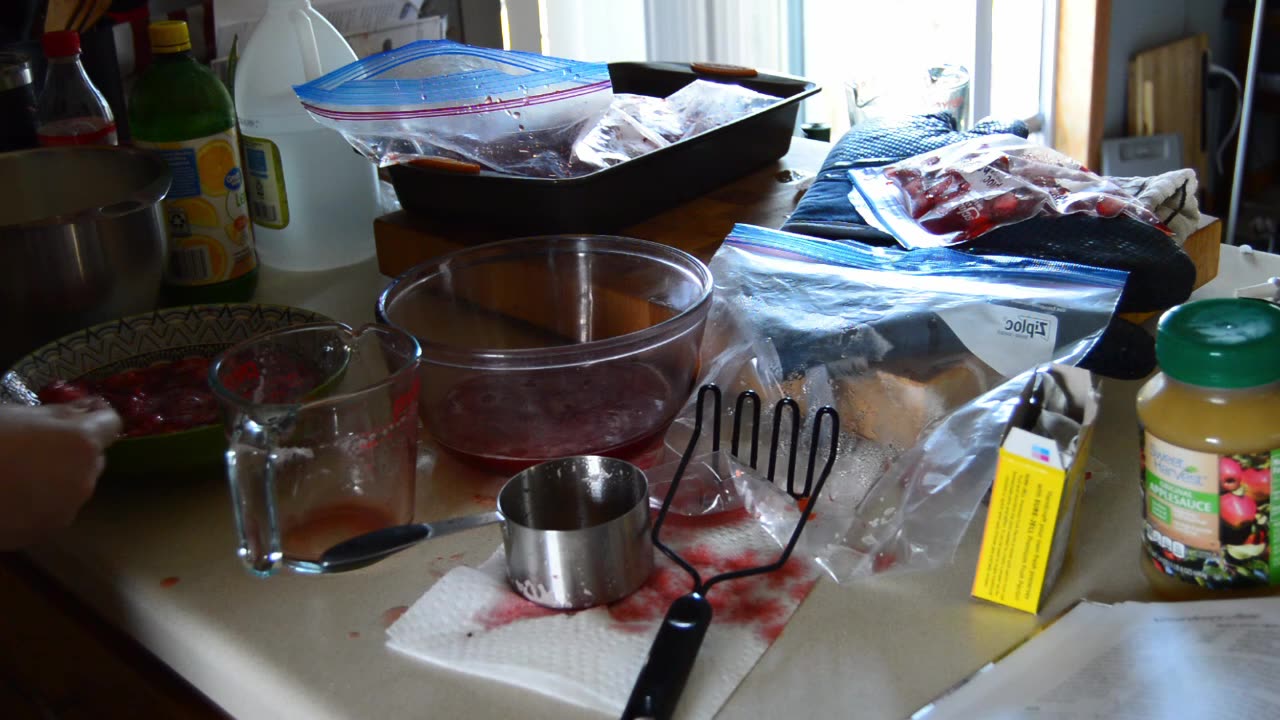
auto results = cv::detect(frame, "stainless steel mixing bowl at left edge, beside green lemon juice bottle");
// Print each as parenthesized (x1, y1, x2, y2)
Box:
(0, 146, 170, 368)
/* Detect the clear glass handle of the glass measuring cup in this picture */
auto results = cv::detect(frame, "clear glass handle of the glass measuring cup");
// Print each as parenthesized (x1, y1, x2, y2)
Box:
(227, 418, 284, 577)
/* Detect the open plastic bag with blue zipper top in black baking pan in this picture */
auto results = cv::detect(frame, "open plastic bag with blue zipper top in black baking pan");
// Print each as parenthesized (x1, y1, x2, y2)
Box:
(293, 40, 613, 177)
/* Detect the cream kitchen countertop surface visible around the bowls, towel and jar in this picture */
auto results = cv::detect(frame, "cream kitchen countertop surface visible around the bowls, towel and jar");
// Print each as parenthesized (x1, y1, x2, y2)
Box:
(12, 211, 1280, 719)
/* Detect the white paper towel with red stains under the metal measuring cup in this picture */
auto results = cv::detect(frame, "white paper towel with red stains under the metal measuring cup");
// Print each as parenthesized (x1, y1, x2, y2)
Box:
(387, 510, 817, 717)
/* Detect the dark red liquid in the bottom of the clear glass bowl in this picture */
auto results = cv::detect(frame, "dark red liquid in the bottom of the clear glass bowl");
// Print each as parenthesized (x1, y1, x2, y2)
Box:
(428, 361, 689, 473)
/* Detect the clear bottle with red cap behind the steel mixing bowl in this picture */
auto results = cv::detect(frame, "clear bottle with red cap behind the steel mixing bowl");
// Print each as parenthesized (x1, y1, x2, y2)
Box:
(36, 31, 116, 146)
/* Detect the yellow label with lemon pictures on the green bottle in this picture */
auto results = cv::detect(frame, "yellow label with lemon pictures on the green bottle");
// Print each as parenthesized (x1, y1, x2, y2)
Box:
(137, 128, 257, 286)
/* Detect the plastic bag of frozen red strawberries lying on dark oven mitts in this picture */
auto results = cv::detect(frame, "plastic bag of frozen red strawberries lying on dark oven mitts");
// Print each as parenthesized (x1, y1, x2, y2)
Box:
(849, 133, 1169, 249)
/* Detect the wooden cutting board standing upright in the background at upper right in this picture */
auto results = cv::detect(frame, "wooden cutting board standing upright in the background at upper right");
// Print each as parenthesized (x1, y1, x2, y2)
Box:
(1129, 33, 1210, 187)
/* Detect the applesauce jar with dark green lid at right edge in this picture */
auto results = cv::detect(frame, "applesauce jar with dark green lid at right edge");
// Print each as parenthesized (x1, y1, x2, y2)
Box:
(1138, 299, 1280, 600)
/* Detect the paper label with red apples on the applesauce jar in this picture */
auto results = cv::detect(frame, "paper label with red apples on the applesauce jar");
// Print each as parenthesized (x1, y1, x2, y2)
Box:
(1140, 430, 1280, 589)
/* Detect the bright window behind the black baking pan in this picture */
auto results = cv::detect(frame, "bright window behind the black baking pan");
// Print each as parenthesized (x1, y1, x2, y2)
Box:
(503, 0, 1057, 141)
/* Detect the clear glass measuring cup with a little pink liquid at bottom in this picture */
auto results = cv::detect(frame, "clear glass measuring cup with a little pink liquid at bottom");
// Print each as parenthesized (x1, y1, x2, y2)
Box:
(210, 323, 421, 577)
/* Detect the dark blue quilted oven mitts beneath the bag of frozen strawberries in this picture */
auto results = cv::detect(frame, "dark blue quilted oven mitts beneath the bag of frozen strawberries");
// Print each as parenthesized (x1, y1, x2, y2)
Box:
(782, 113, 1196, 379)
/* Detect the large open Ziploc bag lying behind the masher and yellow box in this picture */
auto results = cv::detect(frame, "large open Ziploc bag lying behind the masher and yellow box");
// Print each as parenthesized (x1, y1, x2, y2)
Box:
(667, 225, 1126, 582)
